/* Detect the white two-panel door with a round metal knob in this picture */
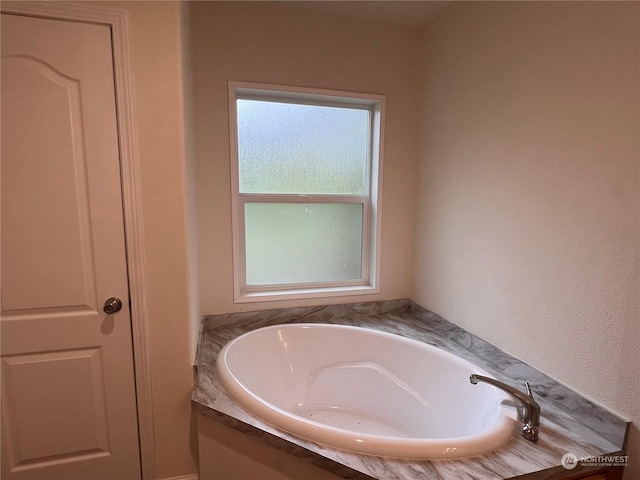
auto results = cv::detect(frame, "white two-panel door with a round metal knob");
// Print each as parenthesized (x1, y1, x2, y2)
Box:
(0, 14, 140, 480)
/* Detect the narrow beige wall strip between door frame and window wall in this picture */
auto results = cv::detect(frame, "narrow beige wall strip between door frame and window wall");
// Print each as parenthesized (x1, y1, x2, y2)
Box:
(91, 2, 197, 478)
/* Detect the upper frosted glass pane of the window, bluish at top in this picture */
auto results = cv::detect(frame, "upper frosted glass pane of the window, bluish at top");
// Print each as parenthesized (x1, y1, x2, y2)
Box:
(236, 99, 370, 195)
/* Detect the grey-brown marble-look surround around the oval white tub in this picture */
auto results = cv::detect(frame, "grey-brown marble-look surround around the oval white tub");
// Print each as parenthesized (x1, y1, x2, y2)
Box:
(193, 300, 627, 480)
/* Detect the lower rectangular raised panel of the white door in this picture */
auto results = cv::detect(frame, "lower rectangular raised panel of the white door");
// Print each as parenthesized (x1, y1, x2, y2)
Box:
(2, 348, 109, 471)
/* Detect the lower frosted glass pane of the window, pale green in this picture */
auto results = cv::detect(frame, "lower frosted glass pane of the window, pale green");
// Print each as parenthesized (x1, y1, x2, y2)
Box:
(245, 203, 363, 285)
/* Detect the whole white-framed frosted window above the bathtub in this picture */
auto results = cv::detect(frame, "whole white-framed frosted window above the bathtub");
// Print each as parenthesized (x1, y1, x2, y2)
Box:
(229, 82, 384, 302)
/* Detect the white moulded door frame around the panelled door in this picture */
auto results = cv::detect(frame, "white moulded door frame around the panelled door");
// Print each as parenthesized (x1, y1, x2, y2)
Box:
(1, 1, 157, 480)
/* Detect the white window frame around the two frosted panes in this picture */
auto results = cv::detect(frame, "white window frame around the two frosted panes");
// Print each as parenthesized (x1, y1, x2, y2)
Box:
(229, 81, 385, 303)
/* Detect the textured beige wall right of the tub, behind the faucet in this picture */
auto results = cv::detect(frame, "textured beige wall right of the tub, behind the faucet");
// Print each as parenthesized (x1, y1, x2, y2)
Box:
(411, 2, 640, 479)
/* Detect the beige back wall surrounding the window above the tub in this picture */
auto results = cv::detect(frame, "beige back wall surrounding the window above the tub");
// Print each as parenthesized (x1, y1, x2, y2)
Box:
(191, 2, 417, 314)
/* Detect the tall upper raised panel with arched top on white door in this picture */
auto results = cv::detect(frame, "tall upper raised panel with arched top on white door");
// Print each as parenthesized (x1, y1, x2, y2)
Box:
(1, 56, 97, 315)
